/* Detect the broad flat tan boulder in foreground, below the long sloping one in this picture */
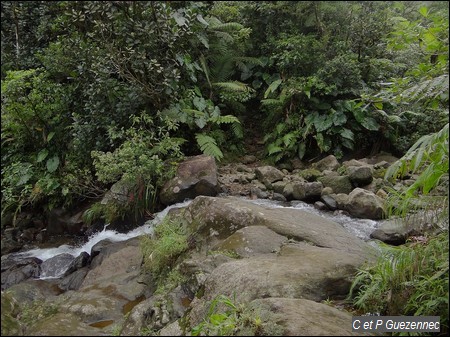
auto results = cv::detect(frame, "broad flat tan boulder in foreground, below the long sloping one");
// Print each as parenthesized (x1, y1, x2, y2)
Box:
(200, 243, 365, 302)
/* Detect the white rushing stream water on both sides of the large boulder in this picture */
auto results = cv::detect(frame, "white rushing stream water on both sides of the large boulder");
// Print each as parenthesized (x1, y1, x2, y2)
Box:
(7, 198, 378, 279)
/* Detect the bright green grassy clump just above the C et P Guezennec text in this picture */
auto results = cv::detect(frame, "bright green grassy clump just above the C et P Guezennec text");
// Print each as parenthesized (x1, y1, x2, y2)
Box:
(350, 231, 449, 332)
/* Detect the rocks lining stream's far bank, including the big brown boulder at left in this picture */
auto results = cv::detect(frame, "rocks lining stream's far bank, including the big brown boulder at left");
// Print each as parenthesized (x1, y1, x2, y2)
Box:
(161, 155, 404, 219)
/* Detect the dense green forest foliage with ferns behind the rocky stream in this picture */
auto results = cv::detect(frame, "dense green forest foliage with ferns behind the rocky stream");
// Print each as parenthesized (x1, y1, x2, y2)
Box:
(1, 1, 448, 222)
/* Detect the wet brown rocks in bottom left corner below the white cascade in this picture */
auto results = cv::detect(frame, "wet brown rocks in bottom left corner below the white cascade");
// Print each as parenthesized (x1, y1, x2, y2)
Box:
(1, 238, 149, 336)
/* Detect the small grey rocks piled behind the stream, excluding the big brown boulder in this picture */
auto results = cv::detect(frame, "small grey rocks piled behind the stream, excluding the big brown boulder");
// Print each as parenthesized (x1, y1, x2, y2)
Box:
(219, 155, 395, 219)
